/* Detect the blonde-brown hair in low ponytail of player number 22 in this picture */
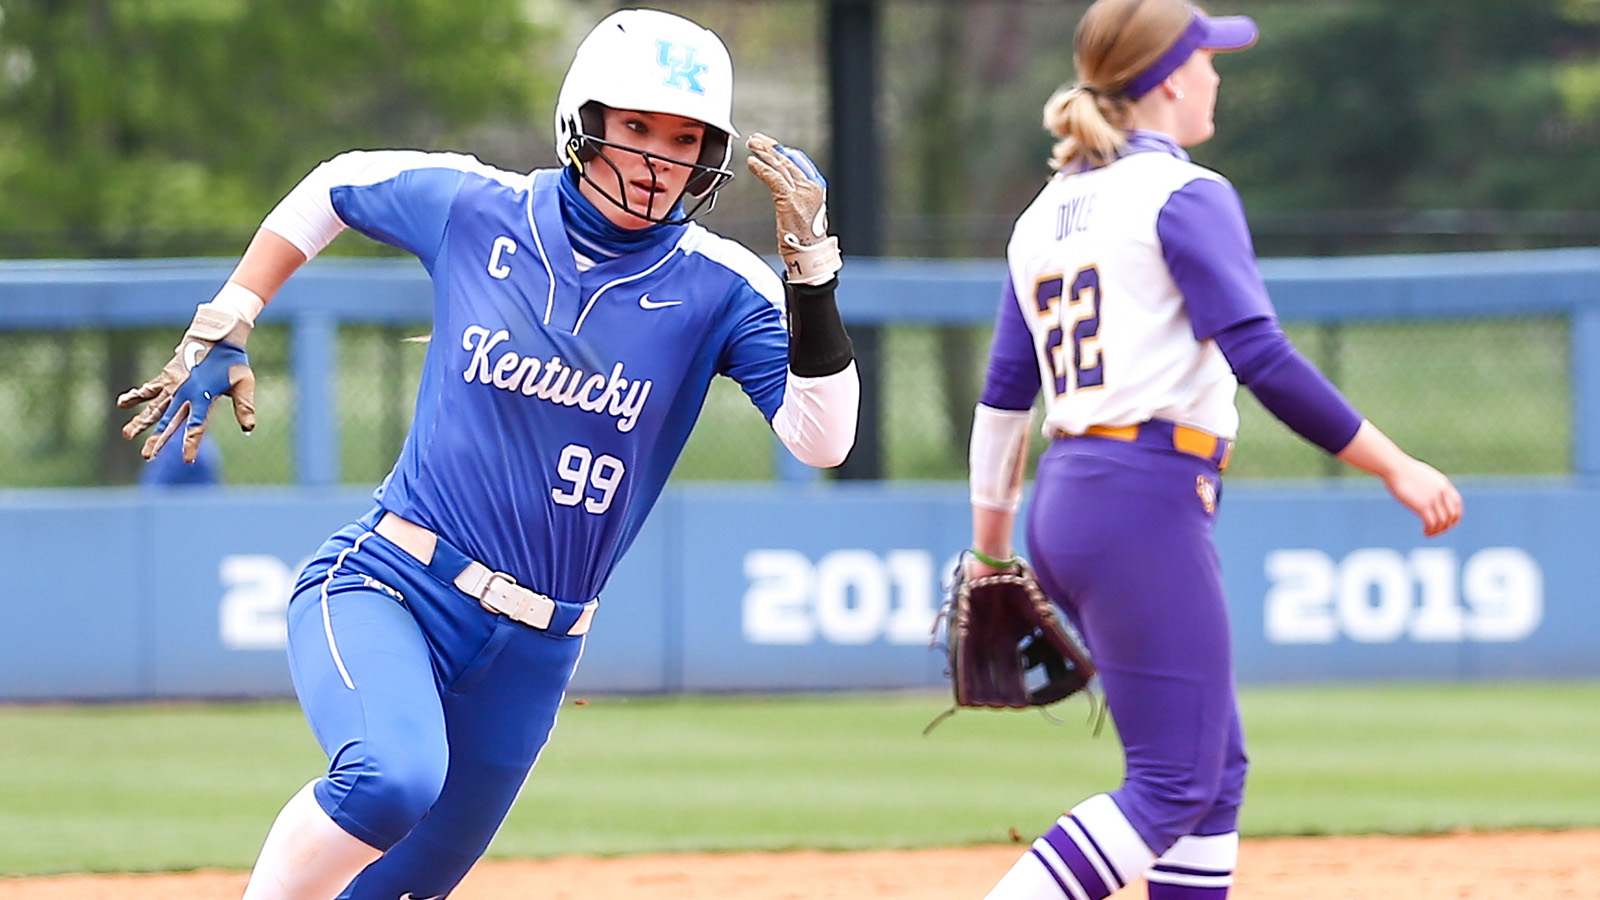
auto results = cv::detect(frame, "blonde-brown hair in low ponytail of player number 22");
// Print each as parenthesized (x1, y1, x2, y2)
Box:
(1043, 0, 1195, 170)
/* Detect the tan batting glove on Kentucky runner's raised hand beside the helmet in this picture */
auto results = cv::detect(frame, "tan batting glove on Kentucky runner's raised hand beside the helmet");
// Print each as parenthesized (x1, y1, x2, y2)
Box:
(744, 133, 843, 285)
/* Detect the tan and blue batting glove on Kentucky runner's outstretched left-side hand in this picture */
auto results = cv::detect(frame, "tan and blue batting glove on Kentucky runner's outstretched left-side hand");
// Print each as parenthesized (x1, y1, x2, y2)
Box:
(117, 282, 264, 463)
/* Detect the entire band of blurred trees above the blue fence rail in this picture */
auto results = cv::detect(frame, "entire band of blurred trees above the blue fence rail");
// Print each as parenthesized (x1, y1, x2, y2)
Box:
(12, 0, 1600, 256)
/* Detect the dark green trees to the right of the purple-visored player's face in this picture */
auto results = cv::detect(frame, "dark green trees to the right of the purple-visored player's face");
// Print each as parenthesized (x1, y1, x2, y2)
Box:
(1197, 0, 1600, 251)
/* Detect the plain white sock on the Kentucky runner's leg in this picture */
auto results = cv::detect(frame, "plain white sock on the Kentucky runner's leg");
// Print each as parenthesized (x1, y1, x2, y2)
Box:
(243, 781, 384, 900)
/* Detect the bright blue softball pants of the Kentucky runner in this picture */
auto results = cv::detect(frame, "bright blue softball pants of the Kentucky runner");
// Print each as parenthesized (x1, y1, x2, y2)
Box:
(288, 509, 584, 900)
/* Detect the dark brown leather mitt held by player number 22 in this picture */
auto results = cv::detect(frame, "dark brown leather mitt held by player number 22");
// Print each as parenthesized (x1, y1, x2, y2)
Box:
(928, 554, 1094, 729)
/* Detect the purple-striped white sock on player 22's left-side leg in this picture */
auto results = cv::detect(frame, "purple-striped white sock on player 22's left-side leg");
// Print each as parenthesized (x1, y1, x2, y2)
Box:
(987, 794, 1155, 900)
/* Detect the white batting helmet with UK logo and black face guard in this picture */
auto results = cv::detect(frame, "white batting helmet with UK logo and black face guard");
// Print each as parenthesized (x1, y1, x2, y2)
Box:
(555, 10, 739, 221)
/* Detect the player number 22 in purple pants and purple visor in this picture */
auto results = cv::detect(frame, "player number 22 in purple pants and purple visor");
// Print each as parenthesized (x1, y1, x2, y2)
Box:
(971, 0, 1461, 900)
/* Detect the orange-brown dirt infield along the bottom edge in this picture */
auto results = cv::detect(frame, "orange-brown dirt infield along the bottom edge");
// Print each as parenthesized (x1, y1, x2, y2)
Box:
(0, 831, 1600, 900)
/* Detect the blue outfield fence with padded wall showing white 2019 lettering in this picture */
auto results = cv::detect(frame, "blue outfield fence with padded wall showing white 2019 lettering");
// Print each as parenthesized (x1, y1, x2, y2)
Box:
(0, 250, 1600, 700)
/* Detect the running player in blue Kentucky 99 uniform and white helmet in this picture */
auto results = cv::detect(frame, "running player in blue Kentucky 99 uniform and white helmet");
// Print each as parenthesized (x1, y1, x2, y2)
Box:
(120, 10, 859, 900)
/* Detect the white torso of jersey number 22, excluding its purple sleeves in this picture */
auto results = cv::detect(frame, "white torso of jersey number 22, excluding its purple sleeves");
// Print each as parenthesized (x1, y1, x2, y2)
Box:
(1006, 146, 1238, 437)
